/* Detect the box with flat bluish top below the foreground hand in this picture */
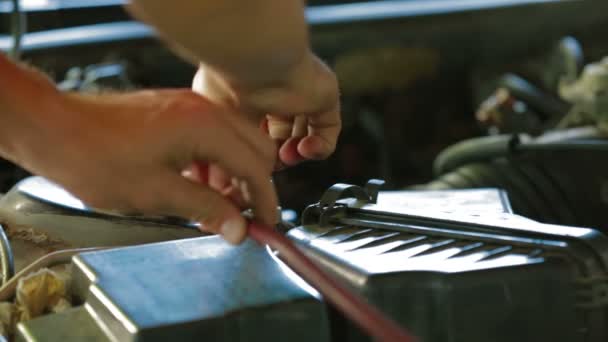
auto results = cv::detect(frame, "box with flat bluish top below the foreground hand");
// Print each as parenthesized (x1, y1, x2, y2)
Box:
(18, 237, 330, 341)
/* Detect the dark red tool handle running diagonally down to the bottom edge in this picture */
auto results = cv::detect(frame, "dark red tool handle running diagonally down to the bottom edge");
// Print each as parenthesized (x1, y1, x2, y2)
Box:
(248, 223, 416, 342)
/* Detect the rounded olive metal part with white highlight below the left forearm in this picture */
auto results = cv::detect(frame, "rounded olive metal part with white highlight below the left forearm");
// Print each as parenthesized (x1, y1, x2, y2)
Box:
(0, 177, 201, 247)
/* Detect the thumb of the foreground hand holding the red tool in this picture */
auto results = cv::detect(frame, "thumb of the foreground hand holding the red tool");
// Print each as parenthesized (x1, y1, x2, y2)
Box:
(159, 171, 247, 244)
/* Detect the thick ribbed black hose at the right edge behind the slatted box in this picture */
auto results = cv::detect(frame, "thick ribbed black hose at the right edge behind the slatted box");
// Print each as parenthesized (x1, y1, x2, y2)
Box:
(428, 127, 608, 231)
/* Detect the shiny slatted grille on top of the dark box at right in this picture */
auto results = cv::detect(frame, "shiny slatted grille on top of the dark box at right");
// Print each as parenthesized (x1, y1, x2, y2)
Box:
(299, 226, 543, 273)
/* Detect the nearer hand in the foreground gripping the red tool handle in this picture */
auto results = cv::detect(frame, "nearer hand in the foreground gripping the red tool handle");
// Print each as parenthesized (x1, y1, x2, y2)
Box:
(8, 82, 277, 243)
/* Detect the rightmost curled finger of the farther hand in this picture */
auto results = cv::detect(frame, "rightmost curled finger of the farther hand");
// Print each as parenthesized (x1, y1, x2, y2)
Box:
(298, 103, 342, 159)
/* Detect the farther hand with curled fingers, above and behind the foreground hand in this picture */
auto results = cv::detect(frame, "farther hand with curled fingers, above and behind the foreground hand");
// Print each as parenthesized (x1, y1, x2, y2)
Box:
(192, 53, 341, 168)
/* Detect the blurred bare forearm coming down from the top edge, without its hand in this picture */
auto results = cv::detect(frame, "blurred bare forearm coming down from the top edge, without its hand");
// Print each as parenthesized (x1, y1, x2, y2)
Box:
(129, 0, 309, 87)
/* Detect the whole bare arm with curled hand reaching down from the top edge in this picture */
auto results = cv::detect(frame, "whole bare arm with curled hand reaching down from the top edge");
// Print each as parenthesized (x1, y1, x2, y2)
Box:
(129, 0, 341, 165)
